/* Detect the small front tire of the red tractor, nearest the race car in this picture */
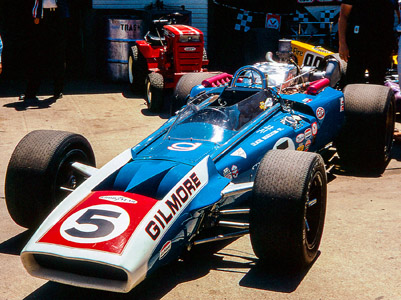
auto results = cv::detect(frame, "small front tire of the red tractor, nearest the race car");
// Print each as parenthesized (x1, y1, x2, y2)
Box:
(145, 72, 164, 112)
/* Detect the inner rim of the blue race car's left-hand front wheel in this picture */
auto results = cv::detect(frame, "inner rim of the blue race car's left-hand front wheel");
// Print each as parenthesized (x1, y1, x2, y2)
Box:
(50, 149, 89, 207)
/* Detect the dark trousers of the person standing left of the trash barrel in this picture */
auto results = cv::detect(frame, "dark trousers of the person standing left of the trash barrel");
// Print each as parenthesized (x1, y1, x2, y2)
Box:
(25, 9, 68, 97)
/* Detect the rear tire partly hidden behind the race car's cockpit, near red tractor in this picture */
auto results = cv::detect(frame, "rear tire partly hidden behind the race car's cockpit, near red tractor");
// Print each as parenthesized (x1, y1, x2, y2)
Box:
(171, 72, 221, 111)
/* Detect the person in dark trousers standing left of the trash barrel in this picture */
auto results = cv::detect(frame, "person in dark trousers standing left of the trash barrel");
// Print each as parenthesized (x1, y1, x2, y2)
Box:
(19, 0, 70, 100)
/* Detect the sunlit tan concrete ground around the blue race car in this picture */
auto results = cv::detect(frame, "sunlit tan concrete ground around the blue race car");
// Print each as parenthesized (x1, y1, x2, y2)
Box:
(0, 81, 401, 300)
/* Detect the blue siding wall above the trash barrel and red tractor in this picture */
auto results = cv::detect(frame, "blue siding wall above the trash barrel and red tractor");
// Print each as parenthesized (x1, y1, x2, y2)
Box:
(92, 0, 208, 47)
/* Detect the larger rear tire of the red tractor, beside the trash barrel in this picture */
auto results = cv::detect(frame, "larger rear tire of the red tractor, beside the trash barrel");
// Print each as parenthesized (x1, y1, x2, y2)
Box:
(128, 45, 149, 92)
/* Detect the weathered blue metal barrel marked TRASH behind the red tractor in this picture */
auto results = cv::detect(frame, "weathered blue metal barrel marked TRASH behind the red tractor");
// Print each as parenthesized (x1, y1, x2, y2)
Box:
(106, 17, 143, 82)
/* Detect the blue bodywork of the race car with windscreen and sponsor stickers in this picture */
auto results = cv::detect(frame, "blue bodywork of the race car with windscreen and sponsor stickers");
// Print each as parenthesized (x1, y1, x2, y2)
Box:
(102, 65, 344, 271)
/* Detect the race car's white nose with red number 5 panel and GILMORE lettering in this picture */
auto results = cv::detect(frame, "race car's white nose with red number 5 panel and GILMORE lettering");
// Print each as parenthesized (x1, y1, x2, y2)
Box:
(21, 157, 229, 292)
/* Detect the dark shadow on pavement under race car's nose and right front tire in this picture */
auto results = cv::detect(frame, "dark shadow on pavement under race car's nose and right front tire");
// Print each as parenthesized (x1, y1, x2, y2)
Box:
(21, 240, 308, 300)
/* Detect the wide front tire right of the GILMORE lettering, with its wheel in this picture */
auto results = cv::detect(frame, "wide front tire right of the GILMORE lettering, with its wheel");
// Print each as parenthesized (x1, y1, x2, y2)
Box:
(249, 150, 327, 273)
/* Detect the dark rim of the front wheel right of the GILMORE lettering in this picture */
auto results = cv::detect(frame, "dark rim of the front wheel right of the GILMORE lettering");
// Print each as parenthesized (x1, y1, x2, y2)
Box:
(304, 172, 323, 250)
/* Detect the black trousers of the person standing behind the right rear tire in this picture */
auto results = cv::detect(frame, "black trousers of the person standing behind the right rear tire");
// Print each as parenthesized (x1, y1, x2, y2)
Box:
(346, 47, 391, 84)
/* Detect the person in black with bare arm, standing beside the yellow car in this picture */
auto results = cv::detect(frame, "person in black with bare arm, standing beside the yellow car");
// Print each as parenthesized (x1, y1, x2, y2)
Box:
(338, 0, 398, 84)
